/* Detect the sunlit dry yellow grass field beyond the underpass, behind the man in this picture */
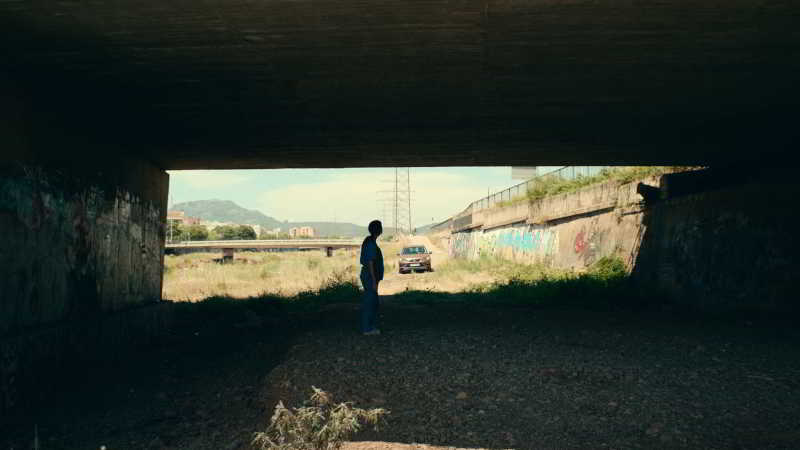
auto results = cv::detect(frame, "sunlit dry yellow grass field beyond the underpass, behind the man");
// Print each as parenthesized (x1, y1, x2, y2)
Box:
(163, 236, 626, 302)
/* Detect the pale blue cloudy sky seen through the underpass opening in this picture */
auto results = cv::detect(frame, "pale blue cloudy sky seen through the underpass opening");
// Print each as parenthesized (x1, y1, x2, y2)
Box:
(169, 167, 536, 227)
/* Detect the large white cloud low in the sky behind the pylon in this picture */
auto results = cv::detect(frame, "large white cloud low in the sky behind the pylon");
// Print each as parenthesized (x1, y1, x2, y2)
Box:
(257, 169, 486, 230)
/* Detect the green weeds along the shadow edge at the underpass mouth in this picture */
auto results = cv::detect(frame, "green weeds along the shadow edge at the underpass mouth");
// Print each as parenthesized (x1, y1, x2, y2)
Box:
(167, 255, 652, 322)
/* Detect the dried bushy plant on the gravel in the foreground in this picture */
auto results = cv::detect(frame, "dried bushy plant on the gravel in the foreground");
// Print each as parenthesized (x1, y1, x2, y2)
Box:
(253, 386, 389, 450)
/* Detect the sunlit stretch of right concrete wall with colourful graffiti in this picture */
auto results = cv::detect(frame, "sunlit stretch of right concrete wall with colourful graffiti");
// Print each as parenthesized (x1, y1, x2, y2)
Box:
(450, 178, 658, 270)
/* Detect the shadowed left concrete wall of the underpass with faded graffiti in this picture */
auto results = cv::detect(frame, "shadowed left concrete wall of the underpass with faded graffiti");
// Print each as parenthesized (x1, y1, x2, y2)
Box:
(0, 77, 169, 412)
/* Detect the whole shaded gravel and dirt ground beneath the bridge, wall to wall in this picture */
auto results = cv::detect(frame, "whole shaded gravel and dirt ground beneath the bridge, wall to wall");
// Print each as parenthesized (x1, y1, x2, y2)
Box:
(0, 301, 800, 450)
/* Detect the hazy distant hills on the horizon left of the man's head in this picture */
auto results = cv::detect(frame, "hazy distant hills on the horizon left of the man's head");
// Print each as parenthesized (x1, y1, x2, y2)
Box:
(170, 200, 367, 237)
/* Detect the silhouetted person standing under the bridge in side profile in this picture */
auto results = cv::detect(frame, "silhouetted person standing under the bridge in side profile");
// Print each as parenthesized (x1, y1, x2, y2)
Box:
(361, 220, 383, 336)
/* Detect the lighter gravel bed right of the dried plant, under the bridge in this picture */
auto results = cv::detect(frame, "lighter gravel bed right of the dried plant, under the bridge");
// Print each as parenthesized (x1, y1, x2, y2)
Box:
(262, 305, 800, 448)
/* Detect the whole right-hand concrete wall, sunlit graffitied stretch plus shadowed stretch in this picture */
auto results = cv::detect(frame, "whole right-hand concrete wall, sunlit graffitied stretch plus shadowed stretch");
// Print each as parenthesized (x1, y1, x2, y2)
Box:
(450, 171, 800, 311)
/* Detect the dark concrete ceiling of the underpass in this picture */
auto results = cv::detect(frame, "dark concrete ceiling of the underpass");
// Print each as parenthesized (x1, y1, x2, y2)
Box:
(0, 0, 800, 169)
